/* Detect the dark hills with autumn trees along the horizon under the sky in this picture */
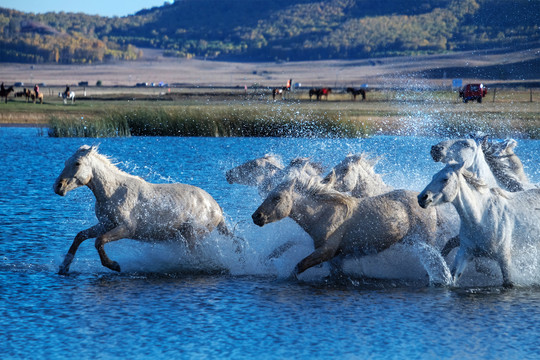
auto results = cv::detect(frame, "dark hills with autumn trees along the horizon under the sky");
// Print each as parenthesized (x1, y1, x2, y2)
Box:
(0, 0, 540, 63)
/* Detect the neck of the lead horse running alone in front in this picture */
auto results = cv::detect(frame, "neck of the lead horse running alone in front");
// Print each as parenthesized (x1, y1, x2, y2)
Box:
(86, 158, 131, 202)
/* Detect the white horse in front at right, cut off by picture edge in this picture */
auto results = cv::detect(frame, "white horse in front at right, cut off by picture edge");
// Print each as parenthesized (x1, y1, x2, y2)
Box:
(418, 163, 540, 287)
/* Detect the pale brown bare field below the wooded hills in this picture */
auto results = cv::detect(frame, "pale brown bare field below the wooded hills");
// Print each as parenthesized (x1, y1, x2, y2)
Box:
(0, 48, 540, 88)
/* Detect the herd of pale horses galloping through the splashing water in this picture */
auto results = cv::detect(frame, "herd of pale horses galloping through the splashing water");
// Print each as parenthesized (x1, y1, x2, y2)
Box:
(54, 137, 540, 287)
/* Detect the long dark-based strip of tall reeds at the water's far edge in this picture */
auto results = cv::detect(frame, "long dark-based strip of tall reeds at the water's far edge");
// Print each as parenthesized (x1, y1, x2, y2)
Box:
(49, 106, 371, 137)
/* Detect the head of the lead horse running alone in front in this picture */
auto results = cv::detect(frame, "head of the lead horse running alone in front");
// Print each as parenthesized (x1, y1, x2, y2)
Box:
(53, 145, 97, 196)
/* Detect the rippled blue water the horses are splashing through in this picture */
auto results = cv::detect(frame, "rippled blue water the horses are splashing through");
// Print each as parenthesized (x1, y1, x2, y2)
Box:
(0, 128, 540, 359)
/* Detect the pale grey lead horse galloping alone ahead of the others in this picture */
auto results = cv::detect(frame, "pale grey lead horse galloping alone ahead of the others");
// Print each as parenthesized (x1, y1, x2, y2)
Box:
(54, 145, 236, 274)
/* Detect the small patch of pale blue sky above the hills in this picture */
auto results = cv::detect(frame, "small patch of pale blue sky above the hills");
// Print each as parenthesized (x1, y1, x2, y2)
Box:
(0, 0, 172, 16)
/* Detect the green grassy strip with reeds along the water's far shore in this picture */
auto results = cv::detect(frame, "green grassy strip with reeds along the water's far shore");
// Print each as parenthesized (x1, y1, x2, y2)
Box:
(0, 88, 540, 138)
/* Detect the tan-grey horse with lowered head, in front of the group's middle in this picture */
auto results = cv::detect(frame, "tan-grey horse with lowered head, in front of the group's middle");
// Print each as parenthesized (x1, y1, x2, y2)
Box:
(252, 165, 450, 284)
